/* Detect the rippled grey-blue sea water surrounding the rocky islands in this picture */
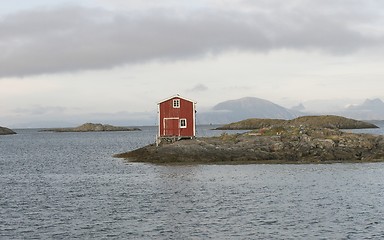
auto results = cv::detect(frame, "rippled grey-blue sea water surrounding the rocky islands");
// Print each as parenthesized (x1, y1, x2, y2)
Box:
(0, 124, 384, 239)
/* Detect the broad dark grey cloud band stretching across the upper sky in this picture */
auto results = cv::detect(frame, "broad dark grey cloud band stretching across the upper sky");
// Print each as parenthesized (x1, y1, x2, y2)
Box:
(0, 0, 384, 78)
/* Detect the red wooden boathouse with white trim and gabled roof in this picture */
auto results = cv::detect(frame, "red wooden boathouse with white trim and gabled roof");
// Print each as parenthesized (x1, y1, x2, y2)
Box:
(157, 95, 196, 139)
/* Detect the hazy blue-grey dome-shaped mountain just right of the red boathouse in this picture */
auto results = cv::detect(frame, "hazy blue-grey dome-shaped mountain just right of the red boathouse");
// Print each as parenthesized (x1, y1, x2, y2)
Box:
(198, 97, 304, 124)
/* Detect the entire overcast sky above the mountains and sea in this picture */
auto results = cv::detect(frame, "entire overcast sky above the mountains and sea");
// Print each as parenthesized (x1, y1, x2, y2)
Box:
(0, 0, 384, 128)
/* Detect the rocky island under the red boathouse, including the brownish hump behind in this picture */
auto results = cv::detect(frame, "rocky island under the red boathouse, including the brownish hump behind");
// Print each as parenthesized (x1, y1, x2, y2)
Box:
(115, 116, 384, 164)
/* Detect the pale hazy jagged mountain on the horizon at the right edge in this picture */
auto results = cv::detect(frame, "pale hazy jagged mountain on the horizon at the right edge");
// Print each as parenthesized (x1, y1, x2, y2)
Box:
(340, 98, 384, 120)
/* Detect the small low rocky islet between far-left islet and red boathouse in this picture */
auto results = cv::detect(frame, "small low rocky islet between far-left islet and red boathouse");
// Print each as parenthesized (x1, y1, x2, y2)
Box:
(42, 123, 141, 132)
